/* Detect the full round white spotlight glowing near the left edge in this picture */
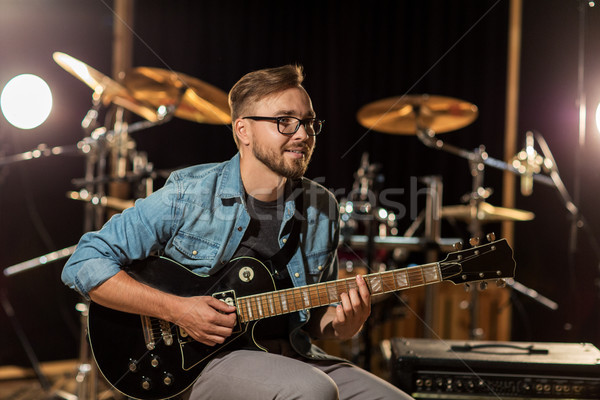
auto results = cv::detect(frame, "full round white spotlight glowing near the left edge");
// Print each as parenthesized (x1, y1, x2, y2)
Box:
(0, 74, 52, 129)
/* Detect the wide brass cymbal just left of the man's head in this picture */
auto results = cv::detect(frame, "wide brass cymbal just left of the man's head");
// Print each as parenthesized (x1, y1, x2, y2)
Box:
(123, 67, 231, 124)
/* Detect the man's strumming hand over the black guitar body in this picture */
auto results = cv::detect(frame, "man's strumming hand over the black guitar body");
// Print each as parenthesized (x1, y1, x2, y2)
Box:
(173, 296, 236, 346)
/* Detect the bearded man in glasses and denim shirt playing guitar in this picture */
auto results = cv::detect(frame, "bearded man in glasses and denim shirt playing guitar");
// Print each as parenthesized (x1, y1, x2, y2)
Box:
(63, 65, 410, 400)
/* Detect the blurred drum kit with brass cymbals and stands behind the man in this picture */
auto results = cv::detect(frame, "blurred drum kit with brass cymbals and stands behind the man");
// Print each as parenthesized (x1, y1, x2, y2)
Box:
(0, 52, 556, 399)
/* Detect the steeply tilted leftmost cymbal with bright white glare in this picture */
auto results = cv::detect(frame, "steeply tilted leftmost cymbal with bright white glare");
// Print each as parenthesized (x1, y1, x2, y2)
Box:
(52, 51, 158, 122)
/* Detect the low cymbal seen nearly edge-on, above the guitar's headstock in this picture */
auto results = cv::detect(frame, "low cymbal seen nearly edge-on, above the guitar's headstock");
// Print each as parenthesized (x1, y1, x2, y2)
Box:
(442, 202, 535, 222)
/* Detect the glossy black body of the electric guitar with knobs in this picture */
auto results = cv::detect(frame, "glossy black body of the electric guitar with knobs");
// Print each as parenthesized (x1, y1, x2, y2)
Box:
(88, 257, 276, 399)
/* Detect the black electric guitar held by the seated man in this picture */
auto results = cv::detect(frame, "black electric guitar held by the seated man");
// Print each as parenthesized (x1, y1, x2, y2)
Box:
(88, 239, 515, 399)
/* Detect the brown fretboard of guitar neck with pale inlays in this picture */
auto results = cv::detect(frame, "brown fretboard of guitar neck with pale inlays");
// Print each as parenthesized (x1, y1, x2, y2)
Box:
(237, 262, 442, 322)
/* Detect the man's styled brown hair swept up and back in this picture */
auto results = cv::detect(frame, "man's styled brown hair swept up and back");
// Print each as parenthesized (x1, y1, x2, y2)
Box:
(229, 65, 304, 145)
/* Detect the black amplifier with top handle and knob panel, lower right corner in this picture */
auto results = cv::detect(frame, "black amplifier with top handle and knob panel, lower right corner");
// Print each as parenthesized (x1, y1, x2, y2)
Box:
(388, 338, 600, 400)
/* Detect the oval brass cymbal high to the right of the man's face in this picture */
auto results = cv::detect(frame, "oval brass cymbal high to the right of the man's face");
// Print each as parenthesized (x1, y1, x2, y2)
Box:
(356, 95, 479, 135)
